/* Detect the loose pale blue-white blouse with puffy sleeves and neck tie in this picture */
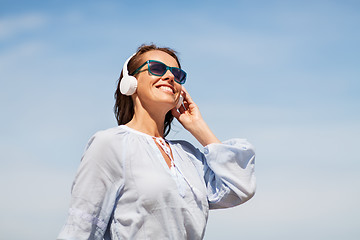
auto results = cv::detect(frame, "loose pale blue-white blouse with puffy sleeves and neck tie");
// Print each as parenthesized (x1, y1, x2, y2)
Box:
(58, 125, 255, 240)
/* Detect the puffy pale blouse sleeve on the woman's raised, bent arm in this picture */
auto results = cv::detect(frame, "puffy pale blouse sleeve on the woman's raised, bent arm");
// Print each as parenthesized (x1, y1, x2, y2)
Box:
(203, 139, 256, 209)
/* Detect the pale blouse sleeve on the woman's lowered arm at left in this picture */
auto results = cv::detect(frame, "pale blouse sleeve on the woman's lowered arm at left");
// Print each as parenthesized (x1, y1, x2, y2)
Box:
(57, 132, 122, 240)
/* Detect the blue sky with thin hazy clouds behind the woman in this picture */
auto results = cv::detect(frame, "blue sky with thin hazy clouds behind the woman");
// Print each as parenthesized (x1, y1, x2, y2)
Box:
(0, 1, 360, 240)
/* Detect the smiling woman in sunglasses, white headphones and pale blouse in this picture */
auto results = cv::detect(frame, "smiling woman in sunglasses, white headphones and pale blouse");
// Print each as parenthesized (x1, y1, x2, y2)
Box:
(58, 45, 255, 239)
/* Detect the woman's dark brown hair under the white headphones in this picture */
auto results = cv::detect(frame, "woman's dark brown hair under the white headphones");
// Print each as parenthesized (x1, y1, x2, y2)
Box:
(114, 44, 181, 137)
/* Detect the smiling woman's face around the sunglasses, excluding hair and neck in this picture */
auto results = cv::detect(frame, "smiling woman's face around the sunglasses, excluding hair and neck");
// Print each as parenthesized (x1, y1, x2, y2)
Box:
(136, 50, 182, 111)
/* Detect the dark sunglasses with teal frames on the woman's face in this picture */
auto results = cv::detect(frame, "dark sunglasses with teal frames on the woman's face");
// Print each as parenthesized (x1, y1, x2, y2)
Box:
(130, 60, 186, 84)
